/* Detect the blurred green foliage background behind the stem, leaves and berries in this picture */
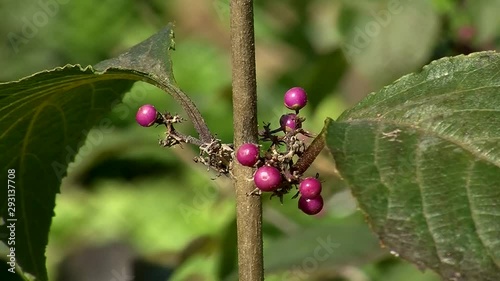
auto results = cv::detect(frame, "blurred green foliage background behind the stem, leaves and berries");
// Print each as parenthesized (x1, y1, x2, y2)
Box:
(0, 0, 500, 281)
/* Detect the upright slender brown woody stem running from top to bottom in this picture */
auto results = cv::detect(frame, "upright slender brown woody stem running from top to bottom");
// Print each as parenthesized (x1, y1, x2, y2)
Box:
(231, 0, 264, 281)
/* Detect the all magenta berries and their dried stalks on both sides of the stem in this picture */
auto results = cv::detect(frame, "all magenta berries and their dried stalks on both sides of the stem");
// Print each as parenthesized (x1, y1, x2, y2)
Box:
(135, 87, 323, 215)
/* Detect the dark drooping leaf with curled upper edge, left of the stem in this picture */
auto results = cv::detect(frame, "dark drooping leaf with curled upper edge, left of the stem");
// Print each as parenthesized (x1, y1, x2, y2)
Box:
(0, 25, 189, 280)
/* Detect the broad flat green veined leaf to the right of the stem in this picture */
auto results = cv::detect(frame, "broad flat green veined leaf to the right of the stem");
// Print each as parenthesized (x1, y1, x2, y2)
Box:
(325, 52, 500, 280)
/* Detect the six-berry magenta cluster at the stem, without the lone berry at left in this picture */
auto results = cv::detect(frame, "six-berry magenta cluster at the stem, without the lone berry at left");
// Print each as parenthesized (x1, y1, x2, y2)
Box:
(236, 87, 323, 215)
